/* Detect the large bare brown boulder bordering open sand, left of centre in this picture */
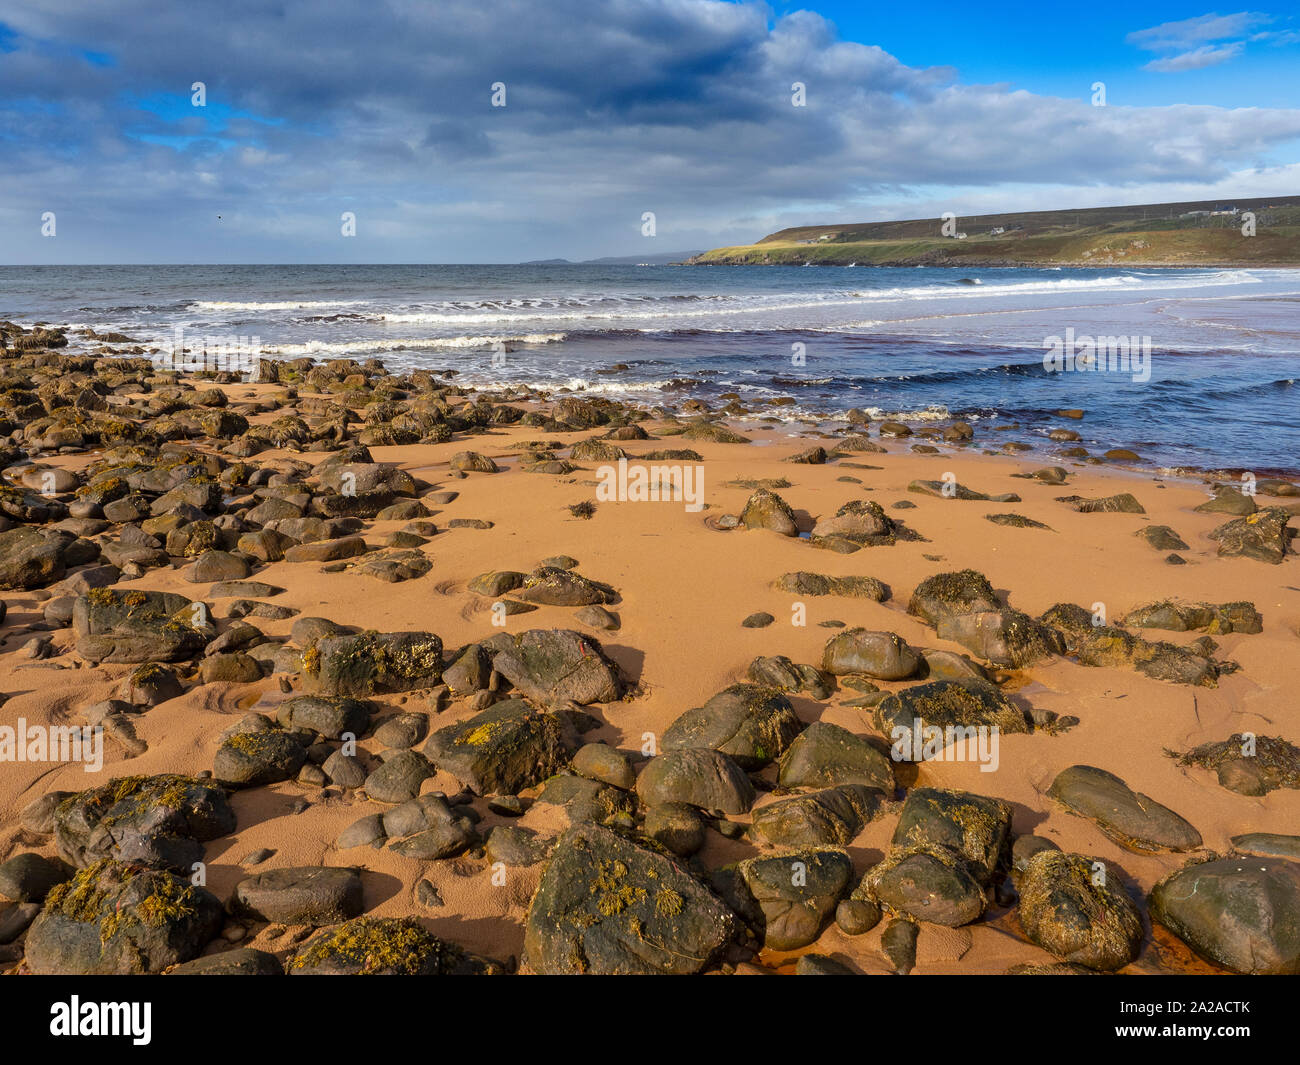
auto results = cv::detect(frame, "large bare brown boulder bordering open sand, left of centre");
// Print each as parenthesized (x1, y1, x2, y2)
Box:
(484, 629, 623, 706)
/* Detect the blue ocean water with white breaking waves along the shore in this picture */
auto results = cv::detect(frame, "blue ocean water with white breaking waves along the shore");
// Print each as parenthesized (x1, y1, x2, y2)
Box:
(0, 265, 1300, 473)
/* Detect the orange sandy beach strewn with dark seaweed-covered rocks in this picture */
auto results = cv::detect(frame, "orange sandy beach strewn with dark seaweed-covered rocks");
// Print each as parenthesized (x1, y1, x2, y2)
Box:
(0, 321, 1300, 974)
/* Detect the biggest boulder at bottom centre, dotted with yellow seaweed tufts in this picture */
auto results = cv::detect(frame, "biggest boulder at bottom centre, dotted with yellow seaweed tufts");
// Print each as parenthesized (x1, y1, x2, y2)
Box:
(524, 824, 737, 975)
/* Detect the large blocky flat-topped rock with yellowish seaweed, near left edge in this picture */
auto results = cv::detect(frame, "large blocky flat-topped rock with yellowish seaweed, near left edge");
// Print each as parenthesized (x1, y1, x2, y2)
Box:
(73, 588, 205, 662)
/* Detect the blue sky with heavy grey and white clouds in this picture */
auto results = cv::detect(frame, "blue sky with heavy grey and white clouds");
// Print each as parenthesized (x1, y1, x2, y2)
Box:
(0, 0, 1300, 264)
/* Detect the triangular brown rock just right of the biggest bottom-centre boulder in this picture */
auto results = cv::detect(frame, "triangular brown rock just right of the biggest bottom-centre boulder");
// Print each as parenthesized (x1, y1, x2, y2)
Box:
(715, 848, 853, 951)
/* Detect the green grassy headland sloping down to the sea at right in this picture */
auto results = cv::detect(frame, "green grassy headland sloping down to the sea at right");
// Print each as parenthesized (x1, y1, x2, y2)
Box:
(686, 196, 1300, 267)
